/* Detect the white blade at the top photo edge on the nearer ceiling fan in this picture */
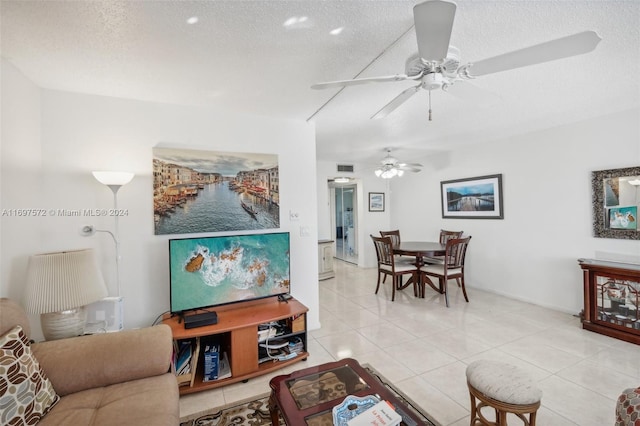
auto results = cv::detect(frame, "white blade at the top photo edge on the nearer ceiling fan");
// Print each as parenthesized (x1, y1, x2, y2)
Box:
(413, 0, 456, 61)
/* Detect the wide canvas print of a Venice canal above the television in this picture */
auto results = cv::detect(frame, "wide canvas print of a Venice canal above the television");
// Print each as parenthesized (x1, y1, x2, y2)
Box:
(153, 148, 280, 235)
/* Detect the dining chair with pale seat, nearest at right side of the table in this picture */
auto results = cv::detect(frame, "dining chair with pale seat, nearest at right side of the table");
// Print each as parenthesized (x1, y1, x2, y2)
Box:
(420, 236, 471, 307)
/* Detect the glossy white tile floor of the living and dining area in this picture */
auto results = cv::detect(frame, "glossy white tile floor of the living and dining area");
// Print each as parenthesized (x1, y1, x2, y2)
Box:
(180, 261, 640, 426)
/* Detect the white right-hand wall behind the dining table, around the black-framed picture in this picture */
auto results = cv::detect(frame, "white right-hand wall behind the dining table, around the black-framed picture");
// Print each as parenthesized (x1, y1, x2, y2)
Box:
(391, 110, 640, 313)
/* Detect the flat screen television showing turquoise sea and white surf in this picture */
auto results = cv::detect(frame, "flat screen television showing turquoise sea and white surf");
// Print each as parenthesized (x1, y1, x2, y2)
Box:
(169, 232, 291, 313)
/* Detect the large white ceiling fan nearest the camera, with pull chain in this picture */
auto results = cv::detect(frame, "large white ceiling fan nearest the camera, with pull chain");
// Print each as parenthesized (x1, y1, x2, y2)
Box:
(311, 0, 601, 121)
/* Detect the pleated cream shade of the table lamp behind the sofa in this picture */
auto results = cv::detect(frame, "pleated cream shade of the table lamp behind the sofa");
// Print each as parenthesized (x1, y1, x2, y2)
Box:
(24, 249, 107, 314)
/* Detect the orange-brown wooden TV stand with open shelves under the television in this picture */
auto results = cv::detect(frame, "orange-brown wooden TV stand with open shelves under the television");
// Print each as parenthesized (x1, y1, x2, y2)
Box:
(162, 297, 309, 394)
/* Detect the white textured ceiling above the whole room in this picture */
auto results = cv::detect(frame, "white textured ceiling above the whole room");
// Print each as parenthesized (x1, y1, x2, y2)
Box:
(0, 0, 640, 167)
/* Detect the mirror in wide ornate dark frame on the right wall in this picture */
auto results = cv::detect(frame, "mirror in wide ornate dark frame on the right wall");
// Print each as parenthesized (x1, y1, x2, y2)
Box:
(591, 167, 640, 240)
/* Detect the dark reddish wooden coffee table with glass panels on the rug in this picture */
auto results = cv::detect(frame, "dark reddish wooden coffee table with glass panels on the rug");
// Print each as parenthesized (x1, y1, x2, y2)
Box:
(269, 358, 427, 426)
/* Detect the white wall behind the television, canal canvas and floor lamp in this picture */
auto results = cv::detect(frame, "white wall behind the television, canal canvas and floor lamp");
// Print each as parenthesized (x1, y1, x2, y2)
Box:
(1, 63, 319, 340)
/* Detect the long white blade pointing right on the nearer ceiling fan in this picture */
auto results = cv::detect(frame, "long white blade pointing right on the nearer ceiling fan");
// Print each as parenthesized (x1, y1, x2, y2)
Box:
(465, 31, 602, 77)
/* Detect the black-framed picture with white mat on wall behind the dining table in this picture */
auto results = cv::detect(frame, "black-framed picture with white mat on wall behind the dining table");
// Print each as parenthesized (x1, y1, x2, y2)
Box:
(440, 174, 504, 219)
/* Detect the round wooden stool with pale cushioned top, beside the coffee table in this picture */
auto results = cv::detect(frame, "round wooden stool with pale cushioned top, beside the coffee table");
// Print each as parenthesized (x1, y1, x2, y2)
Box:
(467, 360, 542, 426)
